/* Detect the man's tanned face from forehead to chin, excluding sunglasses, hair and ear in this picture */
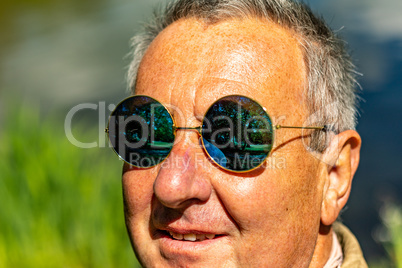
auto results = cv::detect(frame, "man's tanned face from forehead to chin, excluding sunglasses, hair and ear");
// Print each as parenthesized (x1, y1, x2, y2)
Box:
(123, 19, 323, 267)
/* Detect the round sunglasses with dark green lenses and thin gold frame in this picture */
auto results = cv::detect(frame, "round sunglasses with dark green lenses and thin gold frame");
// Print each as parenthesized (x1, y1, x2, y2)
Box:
(105, 95, 327, 172)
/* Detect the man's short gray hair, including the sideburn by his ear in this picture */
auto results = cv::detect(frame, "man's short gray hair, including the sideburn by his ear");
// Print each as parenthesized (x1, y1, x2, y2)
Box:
(127, 0, 358, 152)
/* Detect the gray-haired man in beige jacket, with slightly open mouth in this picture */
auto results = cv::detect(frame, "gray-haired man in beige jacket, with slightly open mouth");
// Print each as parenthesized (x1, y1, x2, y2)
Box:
(109, 0, 366, 267)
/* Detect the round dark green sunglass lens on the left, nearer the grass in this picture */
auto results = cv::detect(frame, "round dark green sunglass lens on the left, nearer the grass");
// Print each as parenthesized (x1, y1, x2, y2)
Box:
(108, 95, 175, 168)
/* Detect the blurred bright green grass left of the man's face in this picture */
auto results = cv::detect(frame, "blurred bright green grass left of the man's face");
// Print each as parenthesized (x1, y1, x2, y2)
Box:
(0, 99, 139, 268)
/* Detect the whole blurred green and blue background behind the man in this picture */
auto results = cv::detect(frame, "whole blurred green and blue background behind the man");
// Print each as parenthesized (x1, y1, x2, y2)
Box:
(0, 0, 402, 267)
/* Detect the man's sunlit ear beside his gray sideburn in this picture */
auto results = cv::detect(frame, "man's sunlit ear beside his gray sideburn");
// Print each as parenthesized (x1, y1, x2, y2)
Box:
(321, 130, 361, 226)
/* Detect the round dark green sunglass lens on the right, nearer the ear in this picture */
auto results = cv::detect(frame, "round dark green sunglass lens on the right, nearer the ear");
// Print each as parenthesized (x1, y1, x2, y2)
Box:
(201, 95, 273, 172)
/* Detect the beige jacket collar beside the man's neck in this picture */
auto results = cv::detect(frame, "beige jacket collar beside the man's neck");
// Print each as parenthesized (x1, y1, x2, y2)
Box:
(333, 223, 368, 268)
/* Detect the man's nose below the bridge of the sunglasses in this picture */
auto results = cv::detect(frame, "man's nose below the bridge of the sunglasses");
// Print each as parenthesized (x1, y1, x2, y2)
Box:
(153, 134, 212, 208)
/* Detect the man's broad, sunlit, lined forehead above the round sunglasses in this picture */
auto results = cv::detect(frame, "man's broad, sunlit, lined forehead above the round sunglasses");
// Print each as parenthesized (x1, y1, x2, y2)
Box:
(136, 19, 306, 120)
